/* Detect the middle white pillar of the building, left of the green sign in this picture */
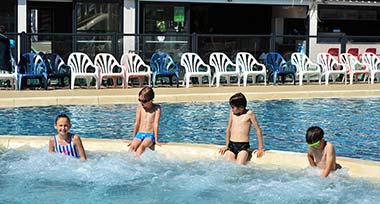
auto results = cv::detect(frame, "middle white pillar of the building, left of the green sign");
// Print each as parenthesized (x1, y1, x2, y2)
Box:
(123, 0, 138, 53)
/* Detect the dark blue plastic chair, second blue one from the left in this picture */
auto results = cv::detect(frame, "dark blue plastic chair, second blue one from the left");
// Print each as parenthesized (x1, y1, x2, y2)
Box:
(42, 53, 71, 86)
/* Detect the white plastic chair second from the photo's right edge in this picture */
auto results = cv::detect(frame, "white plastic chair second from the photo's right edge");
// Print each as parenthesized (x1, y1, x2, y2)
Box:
(339, 53, 370, 85)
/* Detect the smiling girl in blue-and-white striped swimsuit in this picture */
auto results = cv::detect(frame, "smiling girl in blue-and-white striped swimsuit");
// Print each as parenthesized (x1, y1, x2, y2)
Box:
(49, 114, 87, 160)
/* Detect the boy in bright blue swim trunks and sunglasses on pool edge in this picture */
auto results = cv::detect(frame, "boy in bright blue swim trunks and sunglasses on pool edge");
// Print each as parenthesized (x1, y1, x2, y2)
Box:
(128, 87, 161, 156)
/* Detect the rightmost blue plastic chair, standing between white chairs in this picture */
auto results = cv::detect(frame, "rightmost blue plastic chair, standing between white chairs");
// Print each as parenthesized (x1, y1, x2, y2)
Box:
(265, 52, 297, 85)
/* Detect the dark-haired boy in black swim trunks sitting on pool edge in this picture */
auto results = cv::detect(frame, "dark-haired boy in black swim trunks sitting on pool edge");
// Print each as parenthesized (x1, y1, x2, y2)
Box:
(219, 93, 264, 164)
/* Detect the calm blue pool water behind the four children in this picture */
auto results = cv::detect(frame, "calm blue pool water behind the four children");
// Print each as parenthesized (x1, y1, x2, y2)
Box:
(0, 98, 380, 160)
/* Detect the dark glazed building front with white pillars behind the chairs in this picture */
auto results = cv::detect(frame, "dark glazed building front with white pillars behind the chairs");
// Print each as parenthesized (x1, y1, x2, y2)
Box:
(0, 0, 380, 59)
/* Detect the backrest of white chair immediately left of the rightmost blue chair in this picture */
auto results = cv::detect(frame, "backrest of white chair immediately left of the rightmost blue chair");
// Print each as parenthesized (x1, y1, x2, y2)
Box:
(236, 52, 263, 72)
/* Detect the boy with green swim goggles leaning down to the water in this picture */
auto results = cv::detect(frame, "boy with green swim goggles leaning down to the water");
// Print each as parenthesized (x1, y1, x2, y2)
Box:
(306, 126, 341, 178)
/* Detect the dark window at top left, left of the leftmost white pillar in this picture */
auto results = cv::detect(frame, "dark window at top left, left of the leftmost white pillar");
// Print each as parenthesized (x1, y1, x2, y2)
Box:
(0, 0, 17, 33)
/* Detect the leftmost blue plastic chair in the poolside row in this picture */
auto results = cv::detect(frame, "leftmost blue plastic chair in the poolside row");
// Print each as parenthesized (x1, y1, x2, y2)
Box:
(18, 52, 47, 89)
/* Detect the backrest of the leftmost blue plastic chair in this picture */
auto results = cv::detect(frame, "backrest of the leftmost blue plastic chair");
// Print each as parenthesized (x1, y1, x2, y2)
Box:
(18, 52, 47, 75)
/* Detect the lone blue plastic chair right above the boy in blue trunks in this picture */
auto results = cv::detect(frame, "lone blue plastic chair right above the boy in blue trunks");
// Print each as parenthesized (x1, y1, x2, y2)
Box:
(150, 52, 179, 87)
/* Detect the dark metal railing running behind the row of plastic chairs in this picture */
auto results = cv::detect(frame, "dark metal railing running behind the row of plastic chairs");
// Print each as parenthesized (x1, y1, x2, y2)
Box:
(8, 32, 380, 62)
